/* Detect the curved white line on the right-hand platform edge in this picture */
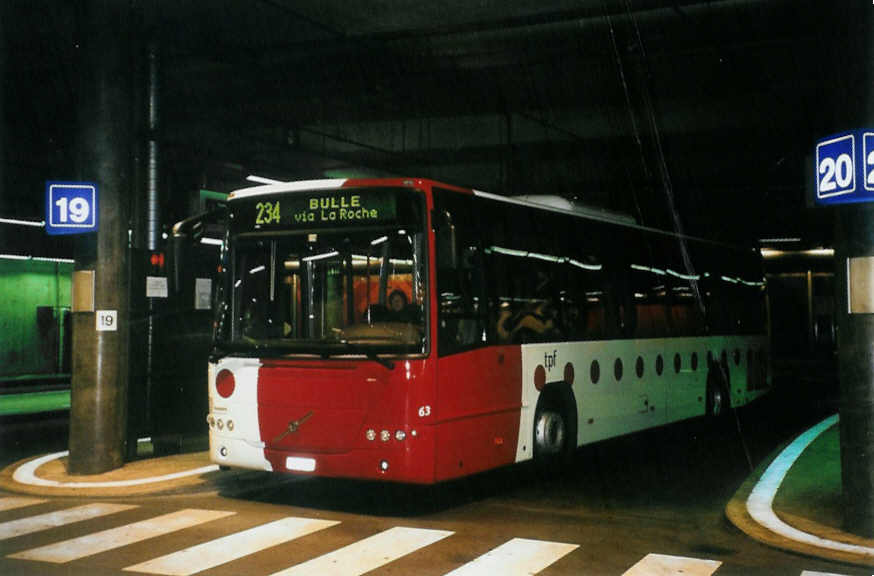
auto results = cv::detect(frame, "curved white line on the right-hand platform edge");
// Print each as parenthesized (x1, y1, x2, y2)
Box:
(747, 414, 874, 559)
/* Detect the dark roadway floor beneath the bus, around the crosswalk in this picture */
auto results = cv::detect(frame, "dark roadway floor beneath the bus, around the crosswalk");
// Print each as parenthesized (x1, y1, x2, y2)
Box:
(0, 372, 871, 576)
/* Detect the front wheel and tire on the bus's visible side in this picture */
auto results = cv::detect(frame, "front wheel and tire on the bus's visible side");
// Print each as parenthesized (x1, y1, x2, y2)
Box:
(534, 384, 577, 473)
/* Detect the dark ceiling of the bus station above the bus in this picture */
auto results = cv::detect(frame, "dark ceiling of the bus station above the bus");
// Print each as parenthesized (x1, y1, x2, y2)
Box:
(0, 0, 872, 252)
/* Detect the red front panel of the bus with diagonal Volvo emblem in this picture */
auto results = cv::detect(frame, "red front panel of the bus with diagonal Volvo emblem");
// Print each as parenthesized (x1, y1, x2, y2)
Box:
(258, 359, 434, 483)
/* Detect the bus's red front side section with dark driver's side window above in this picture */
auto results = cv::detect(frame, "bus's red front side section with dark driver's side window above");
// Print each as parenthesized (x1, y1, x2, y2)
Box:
(434, 196, 521, 480)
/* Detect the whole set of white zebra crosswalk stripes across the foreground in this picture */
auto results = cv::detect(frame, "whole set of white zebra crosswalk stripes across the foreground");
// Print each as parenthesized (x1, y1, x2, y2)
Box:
(0, 504, 846, 576)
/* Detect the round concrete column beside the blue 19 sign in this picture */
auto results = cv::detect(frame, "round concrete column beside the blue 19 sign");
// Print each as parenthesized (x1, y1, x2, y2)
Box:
(69, 0, 132, 474)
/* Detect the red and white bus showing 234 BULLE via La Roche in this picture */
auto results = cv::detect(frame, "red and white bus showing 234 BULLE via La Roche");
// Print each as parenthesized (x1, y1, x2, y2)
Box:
(201, 179, 770, 484)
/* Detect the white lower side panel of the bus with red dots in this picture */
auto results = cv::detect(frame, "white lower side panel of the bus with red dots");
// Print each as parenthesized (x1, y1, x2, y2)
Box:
(516, 336, 769, 462)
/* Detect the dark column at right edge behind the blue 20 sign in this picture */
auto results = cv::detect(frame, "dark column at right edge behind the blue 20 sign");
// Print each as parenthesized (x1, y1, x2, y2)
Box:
(835, 3, 874, 538)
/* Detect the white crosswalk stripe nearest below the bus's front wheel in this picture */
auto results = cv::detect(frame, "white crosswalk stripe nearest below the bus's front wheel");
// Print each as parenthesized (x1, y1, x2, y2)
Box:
(446, 538, 579, 576)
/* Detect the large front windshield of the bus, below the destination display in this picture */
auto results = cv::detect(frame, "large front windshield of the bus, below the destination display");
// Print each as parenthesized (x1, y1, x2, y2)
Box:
(216, 196, 427, 356)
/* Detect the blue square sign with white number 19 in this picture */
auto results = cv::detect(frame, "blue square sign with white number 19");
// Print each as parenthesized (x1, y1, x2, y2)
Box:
(46, 182, 97, 235)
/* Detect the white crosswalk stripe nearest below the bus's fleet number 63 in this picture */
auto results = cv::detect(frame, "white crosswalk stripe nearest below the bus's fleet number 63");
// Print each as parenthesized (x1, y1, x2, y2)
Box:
(272, 527, 453, 576)
